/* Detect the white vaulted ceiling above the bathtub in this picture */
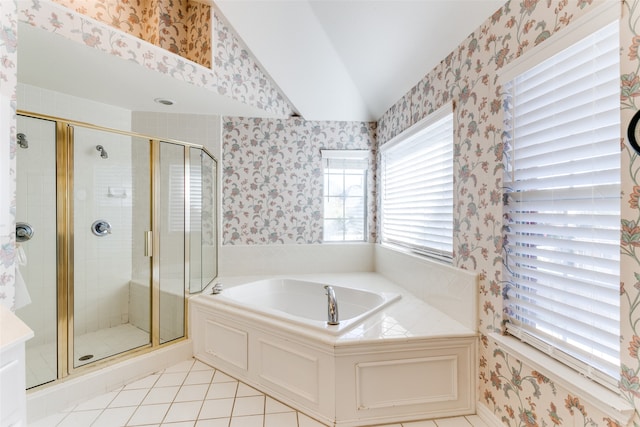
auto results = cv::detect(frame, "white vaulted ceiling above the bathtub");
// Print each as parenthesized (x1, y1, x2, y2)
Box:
(214, 0, 505, 121)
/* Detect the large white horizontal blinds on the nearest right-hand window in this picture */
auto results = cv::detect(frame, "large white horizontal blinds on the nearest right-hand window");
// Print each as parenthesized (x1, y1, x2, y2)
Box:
(504, 22, 620, 388)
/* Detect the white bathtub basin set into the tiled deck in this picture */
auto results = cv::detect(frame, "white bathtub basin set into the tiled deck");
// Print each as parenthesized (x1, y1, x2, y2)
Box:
(213, 278, 400, 335)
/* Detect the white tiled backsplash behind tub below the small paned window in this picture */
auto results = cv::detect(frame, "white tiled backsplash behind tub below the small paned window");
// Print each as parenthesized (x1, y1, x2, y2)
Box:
(218, 243, 374, 278)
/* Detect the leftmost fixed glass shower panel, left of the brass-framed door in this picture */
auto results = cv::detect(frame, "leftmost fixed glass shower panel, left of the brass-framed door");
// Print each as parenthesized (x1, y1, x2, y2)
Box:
(15, 116, 58, 388)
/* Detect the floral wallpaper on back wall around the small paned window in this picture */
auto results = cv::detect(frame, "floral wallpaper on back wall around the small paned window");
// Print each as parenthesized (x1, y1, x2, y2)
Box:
(222, 117, 376, 245)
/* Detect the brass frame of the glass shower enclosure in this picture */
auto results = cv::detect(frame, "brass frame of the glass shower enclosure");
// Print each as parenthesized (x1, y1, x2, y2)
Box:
(17, 110, 212, 389)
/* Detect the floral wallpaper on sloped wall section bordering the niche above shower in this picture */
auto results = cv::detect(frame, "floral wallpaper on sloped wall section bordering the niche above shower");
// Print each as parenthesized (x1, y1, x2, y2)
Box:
(18, 0, 294, 117)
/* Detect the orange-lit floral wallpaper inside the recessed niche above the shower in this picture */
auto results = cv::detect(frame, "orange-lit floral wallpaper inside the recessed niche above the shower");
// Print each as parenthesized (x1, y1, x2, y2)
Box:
(53, 0, 211, 68)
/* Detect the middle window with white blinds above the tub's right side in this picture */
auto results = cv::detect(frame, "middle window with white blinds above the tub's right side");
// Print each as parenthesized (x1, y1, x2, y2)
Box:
(380, 105, 453, 262)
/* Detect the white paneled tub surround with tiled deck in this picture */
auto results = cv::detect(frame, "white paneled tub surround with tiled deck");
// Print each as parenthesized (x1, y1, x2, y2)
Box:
(189, 273, 477, 427)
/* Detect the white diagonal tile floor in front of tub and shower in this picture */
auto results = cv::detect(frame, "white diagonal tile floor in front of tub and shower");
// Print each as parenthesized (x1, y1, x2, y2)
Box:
(29, 360, 487, 427)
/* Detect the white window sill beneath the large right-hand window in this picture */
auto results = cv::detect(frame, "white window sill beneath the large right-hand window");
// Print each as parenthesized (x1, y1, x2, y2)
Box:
(489, 333, 634, 426)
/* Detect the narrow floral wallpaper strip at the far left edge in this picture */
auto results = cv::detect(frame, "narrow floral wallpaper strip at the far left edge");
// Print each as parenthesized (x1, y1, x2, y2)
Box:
(0, 1, 18, 309)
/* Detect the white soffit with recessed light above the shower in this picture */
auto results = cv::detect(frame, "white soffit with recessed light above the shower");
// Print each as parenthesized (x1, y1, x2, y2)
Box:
(18, 21, 268, 117)
